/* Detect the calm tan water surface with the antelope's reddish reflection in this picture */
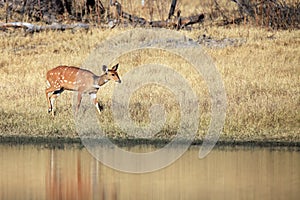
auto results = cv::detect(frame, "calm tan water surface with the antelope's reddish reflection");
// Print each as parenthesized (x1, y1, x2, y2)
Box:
(0, 145, 300, 200)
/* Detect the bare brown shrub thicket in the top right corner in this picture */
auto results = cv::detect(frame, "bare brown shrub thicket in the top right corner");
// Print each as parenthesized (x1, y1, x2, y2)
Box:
(214, 0, 300, 29)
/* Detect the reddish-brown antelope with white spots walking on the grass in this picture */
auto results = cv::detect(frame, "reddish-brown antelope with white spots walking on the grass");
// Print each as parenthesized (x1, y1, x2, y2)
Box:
(46, 64, 121, 116)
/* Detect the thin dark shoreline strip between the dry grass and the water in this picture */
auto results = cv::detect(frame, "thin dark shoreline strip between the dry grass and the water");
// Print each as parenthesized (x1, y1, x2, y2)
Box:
(0, 136, 300, 150)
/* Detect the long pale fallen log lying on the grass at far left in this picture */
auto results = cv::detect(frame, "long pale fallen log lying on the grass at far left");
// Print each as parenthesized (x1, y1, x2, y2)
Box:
(0, 22, 89, 33)
